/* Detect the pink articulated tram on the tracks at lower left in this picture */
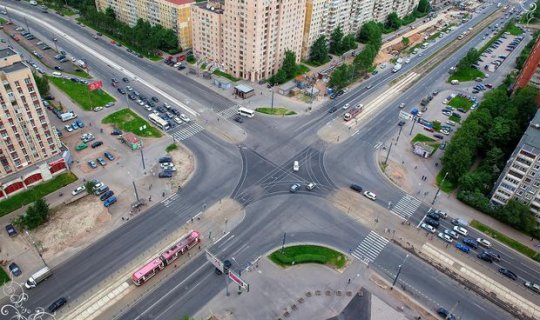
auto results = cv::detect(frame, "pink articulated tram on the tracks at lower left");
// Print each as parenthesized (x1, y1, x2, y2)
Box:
(131, 231, 201, 286)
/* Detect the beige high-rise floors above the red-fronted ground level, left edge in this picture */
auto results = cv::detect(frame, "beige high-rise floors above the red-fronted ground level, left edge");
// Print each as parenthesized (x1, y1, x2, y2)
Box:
(0, 48, 61, 179)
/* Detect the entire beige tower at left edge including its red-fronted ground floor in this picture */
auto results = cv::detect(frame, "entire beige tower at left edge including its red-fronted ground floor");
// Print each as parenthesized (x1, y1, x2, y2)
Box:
(0, 48, 68, 199)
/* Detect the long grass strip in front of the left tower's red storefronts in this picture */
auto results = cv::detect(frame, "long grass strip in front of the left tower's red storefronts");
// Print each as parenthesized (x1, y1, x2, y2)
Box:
(0, 172, 77, 217)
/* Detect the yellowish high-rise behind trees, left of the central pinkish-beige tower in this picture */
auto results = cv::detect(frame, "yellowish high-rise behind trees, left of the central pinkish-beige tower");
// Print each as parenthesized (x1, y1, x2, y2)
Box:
(96, 0, 194, 48)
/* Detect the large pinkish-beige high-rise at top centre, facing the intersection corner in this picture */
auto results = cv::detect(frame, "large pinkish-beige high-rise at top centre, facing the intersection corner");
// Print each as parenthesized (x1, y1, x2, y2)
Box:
(192, 0, 306, 81)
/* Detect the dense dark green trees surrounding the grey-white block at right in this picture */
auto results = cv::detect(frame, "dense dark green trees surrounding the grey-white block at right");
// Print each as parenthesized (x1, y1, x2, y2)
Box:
(441, 83, 540, 237)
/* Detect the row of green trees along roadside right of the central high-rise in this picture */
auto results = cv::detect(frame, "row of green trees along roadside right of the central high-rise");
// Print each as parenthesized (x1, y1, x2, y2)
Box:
(328, 21, 382, 90)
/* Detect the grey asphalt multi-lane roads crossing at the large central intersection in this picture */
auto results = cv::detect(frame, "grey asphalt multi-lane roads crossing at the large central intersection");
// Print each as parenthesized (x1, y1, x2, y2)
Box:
(2, 1, 540, 319)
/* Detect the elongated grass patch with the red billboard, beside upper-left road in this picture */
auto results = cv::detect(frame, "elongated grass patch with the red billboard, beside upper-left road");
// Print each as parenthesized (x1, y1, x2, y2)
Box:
(47, 76, 116, 111)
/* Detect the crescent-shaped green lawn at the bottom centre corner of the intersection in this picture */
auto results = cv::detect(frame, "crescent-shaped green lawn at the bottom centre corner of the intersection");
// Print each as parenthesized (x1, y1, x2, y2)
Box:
(270, 245, 347, 269)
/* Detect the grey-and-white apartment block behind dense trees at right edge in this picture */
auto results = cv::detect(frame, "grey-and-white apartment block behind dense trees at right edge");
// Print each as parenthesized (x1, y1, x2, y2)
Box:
(491, 111, 540, 224)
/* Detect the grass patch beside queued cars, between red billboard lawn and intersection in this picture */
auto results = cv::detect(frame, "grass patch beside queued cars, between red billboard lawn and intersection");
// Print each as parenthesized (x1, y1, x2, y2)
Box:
(101, 108, 161, 138)
